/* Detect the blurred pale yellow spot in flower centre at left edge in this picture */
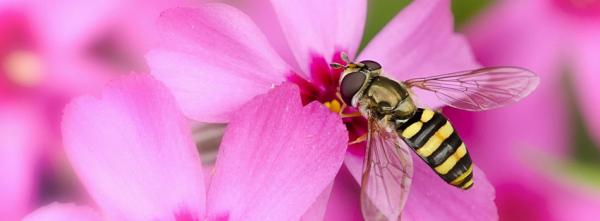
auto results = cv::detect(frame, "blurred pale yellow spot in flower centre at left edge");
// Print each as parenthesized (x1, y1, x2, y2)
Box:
(2, 50, 42, 87)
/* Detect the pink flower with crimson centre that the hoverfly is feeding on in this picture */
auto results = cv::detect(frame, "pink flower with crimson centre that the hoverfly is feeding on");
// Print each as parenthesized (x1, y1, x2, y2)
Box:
(147, 0, 496, 220)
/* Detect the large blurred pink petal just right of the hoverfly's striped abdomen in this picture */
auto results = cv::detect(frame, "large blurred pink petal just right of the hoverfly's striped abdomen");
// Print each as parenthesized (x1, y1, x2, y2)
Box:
(460, 1, 569, 178)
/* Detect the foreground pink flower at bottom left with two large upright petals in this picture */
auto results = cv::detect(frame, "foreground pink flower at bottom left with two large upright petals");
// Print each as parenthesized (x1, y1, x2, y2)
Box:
(25, 76, 348, 221)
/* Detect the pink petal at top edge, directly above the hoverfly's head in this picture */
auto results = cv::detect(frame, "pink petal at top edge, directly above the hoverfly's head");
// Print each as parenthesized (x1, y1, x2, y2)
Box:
(271, 0, 367, 73)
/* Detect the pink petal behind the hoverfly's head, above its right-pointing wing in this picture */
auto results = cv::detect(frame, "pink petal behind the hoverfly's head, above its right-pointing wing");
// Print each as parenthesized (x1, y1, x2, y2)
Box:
(359, 0, 479, 108)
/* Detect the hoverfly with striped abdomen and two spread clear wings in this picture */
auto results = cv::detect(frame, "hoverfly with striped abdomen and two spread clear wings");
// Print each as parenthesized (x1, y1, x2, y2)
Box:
(331, 54, 539, 220)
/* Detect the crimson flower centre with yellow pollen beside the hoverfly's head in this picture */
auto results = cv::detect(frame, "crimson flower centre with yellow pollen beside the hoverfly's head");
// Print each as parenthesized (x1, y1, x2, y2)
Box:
(288, 52, 367, 145)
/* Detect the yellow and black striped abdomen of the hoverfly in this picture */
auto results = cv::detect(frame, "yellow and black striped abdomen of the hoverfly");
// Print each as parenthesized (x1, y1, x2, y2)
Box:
(397, 108, 473, 189)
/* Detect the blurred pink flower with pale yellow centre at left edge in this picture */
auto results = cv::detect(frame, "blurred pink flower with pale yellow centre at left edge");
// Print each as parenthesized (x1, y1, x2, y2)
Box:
(0, 0, 191, 221)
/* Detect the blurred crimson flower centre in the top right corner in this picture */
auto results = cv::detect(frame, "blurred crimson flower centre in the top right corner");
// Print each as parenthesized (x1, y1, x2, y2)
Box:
(553, 0, 600, 18)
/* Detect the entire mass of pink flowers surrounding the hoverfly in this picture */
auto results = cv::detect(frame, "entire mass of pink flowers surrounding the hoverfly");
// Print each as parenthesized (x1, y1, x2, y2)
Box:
(0, 0, 600, 221)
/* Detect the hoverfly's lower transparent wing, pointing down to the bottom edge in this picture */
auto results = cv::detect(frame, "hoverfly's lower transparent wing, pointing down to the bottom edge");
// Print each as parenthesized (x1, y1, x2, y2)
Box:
(361, 116, 413, 221)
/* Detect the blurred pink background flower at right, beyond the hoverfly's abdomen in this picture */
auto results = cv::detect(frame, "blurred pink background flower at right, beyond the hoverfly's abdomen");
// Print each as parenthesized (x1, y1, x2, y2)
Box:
(449, 0, 600, 220)
